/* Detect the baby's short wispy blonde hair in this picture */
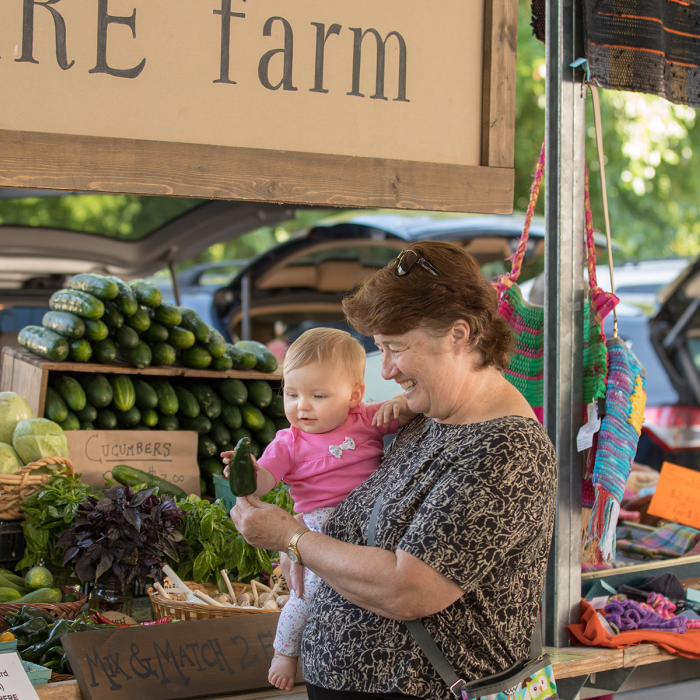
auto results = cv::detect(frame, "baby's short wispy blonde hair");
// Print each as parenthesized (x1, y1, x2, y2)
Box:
(284, 328, 365, 386)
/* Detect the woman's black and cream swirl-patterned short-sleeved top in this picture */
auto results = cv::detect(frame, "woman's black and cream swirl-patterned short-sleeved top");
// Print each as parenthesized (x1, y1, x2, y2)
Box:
(302, 416, 557, 700)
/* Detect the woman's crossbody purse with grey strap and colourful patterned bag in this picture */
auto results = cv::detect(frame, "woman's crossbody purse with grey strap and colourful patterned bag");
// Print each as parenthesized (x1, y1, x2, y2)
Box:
(367, 491, 559, 700)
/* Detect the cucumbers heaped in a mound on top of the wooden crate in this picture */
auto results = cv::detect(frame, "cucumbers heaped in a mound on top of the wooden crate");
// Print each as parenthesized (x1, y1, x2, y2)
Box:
(18, 274, 277, 372)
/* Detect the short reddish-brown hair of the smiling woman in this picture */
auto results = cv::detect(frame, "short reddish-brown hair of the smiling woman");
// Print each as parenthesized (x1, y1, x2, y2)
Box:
(343, 241, 513, 370)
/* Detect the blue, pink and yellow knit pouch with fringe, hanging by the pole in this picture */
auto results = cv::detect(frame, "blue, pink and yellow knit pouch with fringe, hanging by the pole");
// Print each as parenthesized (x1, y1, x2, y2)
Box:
(584, 338, 647, 563)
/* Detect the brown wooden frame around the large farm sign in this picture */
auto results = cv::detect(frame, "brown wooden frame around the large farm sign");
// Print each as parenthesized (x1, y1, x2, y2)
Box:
(0, 0, 518, 214)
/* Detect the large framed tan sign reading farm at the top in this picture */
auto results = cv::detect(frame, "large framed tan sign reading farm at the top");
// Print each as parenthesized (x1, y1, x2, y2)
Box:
(0, 0, 517, 213)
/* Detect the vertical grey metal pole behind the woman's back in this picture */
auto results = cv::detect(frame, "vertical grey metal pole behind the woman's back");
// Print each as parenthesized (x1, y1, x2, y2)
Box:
(544, 0, 585, 647)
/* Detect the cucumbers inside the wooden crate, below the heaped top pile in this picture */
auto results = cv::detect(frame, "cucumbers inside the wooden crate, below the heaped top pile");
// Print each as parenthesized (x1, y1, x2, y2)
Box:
(44, 372, 289, 492)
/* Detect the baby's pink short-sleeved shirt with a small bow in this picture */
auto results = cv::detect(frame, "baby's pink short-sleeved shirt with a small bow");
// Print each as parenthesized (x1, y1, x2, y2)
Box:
(258, 403, 399, 513)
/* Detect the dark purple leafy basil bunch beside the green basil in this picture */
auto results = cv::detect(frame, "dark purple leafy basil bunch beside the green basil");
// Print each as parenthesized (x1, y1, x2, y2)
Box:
(57, 485, 187, 585)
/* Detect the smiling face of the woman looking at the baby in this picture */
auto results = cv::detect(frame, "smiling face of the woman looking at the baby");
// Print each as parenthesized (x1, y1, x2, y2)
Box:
(374, 329, 465, 421)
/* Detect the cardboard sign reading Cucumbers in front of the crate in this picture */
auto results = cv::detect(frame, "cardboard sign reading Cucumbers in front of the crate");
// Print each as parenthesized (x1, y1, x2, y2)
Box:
(66, 430, 200, 495)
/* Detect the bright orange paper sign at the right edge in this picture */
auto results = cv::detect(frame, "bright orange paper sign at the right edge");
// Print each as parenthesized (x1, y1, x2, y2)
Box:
(648, 462, 700, 529)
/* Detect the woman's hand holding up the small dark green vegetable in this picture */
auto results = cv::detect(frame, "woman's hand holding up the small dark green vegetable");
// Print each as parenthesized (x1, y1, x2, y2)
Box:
(231, 496, 299, 552)
